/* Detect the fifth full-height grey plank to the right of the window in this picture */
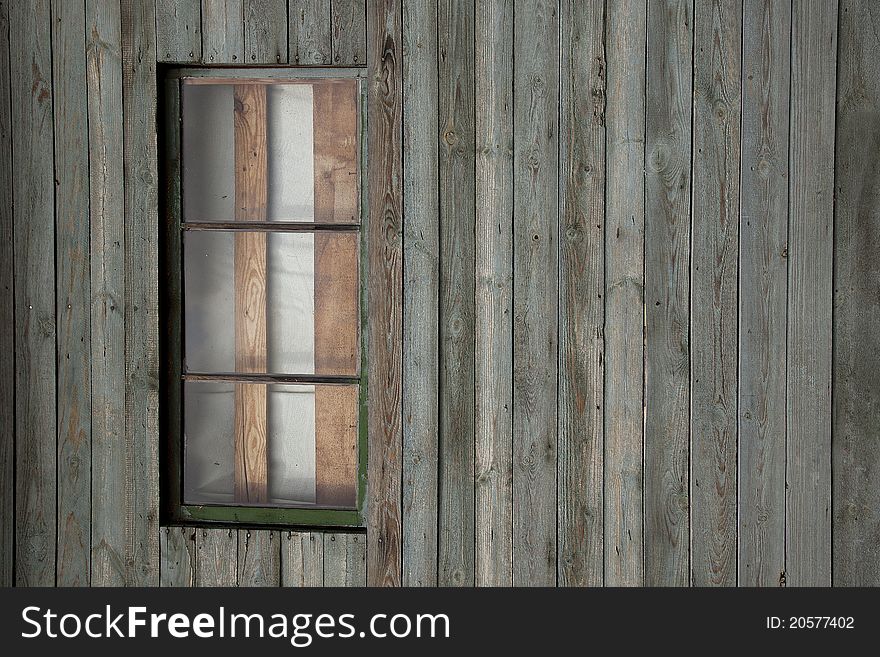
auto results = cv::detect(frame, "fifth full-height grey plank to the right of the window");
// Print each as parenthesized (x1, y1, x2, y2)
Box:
(513, 0, 559, 586)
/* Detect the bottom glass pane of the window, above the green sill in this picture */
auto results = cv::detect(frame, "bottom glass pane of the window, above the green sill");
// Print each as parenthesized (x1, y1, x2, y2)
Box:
(184, 381, 358, 508)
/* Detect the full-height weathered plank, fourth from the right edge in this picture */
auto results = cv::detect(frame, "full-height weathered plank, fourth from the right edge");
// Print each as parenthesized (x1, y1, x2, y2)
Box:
(690, 0, 742, 586)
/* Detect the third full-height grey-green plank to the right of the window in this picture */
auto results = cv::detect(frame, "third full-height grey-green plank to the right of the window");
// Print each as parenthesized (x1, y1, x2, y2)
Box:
(438, 0, 475, 586)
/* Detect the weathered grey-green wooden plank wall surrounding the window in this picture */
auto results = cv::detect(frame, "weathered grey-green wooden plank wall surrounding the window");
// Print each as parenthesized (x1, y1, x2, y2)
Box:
(0, 0, 880, 586)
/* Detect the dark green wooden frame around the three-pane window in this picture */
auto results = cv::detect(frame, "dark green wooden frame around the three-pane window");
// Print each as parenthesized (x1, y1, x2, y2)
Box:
(159, 66, 369, 528)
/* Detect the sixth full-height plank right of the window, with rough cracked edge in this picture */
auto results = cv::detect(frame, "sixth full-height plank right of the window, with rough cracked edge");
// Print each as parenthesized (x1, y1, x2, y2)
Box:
(557, 0, 605, 586)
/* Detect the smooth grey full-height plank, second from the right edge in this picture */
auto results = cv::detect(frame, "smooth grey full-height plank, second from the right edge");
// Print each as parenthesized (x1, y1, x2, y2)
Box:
(785, 0, 837, 586)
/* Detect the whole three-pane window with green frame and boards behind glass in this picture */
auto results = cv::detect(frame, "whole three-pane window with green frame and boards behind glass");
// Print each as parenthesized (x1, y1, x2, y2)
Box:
(164, 69, 366, 526)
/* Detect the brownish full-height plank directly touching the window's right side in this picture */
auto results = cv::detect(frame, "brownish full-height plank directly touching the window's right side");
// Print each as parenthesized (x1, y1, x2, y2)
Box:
(367, 0, 403, 586)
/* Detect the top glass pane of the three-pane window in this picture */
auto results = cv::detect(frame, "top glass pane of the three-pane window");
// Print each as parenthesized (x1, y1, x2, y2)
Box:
(183, 78, 360, 223)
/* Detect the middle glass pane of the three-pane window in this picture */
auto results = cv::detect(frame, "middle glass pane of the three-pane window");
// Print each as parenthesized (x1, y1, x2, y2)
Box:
(184, 230, 360, 376)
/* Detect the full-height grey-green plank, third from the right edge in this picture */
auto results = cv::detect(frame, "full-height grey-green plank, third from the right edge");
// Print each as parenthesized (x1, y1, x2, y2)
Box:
(738, 0, 791, 586)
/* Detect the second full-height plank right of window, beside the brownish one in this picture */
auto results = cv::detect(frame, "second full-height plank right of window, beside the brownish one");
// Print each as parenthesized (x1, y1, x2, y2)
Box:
(400, 0, 440, 586)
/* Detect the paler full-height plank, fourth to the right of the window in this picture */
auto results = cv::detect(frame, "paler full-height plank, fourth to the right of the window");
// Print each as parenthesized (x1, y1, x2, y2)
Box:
(474, 0, 514, 586)
